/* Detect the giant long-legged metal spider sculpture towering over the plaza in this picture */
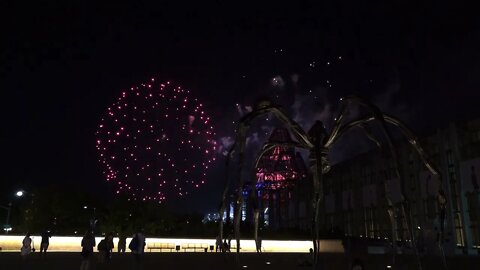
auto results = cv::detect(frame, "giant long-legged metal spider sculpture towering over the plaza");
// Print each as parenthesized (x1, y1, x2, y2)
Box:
(219, 96, 446, 269)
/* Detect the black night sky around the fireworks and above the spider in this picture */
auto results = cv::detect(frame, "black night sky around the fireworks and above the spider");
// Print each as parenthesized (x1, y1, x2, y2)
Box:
(0, 1, 480, 211)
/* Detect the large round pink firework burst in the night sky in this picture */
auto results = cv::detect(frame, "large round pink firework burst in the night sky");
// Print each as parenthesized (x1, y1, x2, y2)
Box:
(96, 79, 216, 202)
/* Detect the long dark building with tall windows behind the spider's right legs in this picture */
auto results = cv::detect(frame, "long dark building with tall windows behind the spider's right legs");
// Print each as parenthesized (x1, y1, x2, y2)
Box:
(323, 120, 480, 254)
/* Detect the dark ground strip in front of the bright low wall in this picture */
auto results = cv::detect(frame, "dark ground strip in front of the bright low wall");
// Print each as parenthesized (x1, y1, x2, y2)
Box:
(0, 252, 480, 270)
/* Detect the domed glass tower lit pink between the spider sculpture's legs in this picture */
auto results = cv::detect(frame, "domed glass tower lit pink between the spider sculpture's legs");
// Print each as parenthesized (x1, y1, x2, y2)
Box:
(242, 128, 311, 230)
